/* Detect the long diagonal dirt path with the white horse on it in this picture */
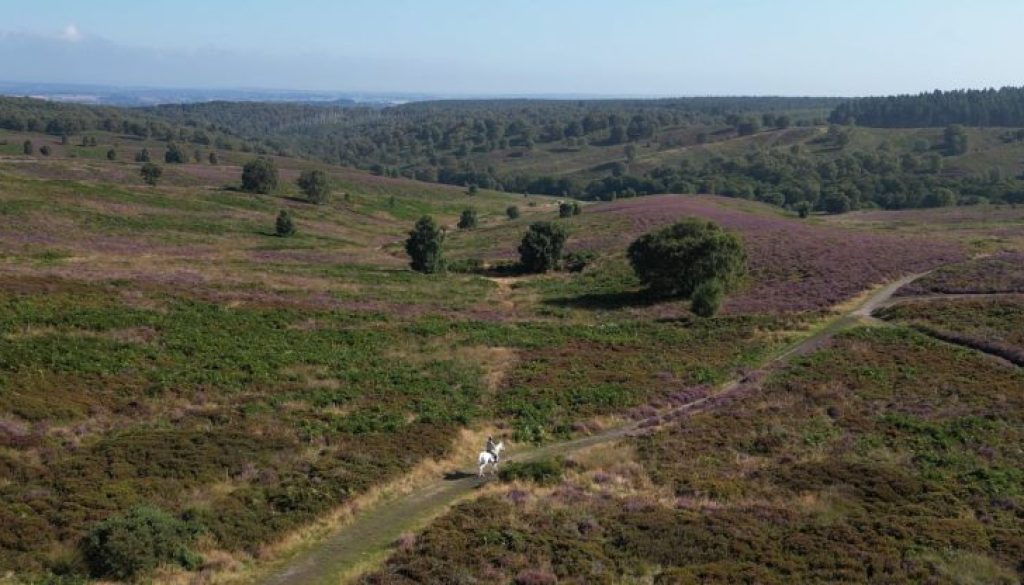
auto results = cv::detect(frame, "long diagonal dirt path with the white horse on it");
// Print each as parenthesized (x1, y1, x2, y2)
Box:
(258, 275, 924, 585)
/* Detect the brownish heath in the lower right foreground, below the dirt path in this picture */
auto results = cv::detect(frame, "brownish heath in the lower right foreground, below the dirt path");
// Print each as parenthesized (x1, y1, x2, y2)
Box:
(362, 329, 1024, 584)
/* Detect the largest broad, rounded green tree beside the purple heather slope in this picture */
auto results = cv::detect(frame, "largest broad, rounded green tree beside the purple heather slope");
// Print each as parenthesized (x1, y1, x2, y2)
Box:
(627, 218, 746, 297)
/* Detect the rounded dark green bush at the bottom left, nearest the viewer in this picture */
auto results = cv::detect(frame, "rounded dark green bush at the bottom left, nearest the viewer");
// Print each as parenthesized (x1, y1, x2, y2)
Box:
(81, 506, 202, 580)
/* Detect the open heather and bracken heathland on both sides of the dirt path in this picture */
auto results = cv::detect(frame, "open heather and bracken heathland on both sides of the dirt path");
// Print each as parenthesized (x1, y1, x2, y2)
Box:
(0, 124, 1022, 584)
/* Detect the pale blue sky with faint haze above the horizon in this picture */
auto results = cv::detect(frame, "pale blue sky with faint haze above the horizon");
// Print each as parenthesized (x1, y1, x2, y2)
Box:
(0, 0, 1024, 96)
